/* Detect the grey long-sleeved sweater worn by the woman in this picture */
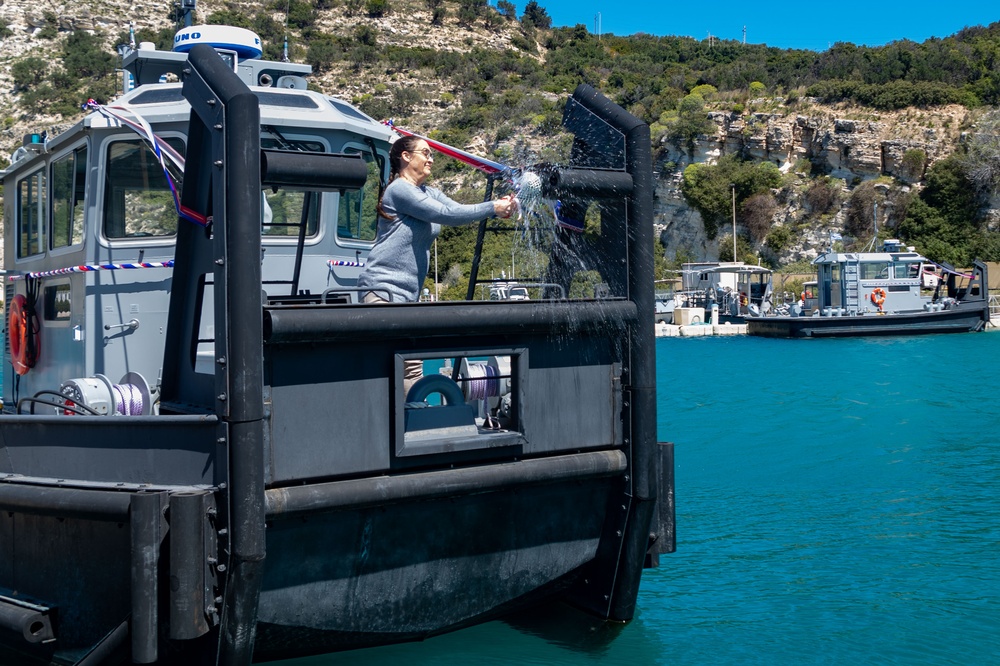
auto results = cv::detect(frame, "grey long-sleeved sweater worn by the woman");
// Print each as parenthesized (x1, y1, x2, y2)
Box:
(358, 178, 494, 303)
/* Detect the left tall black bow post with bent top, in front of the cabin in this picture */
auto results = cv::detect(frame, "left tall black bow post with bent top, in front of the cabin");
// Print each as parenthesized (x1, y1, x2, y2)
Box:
(180, 45, 265, 666)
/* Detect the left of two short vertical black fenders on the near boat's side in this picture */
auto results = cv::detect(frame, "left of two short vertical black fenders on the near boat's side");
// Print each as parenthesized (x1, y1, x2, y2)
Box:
(129, 492, 167, 664)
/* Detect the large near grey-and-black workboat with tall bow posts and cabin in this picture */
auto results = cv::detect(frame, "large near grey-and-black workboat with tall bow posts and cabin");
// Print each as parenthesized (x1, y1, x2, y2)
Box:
(0, 26, 673, 665)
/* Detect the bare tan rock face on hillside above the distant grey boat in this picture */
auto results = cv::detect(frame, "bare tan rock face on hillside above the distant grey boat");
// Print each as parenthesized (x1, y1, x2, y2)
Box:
(655, 99, 975, 263)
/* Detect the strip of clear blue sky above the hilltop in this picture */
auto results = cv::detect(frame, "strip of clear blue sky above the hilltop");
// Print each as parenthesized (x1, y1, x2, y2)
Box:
(536, 0, 1000, 51)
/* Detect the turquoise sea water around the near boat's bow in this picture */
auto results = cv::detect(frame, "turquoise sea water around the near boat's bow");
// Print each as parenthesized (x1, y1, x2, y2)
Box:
(282, 333, 1000, 666)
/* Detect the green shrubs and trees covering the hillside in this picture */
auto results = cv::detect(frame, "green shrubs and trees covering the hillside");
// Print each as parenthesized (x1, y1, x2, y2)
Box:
(11, 0, 1000, 271)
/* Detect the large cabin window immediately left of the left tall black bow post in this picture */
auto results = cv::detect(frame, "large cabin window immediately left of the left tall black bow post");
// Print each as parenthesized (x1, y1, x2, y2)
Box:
(104, 138, 184, 239)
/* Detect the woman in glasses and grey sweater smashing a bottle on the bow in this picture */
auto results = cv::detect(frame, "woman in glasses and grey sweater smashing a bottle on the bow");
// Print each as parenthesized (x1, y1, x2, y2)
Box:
(358, 136, 517, 303)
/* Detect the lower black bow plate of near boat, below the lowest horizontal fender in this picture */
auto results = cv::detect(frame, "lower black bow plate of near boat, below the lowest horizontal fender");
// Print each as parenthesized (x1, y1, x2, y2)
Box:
(254, 480, 609, 660)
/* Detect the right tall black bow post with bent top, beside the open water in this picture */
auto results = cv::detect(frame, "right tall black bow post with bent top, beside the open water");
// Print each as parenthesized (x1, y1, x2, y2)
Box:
(573, 84, 660, 621)
